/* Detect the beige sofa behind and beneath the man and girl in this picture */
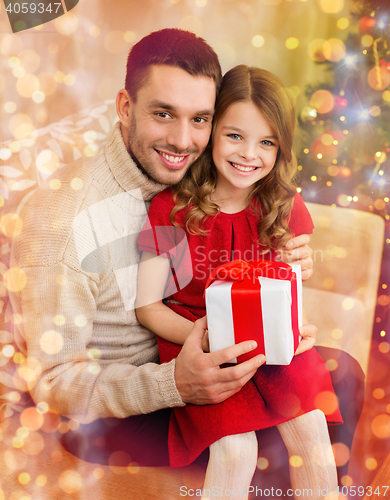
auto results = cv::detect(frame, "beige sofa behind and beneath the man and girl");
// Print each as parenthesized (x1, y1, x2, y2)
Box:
(0, 101, 384, 500)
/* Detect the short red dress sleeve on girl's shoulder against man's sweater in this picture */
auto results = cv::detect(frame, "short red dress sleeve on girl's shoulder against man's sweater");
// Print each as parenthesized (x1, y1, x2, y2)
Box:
(137, 191, 181, 259)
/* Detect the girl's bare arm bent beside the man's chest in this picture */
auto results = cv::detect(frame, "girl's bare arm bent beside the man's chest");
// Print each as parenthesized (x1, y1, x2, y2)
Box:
(136, 252, 194, 345)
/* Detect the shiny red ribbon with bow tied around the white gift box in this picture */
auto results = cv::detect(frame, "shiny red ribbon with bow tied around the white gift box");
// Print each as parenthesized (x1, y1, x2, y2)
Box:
(205, 259, 299, 363)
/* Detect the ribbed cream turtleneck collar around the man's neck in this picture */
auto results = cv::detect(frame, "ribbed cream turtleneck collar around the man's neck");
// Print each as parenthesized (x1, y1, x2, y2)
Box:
(104, 121, 166, 201)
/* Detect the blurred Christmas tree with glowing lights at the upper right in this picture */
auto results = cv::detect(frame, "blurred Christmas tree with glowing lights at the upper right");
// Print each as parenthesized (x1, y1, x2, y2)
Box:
(298, 0, 390, 224)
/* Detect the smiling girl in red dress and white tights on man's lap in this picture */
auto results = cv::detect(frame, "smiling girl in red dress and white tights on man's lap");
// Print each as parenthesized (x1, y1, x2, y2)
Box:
(137, 65, 342, 499)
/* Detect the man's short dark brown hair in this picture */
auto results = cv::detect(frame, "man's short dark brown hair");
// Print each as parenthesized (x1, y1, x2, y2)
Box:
(125, 28, 222, 102)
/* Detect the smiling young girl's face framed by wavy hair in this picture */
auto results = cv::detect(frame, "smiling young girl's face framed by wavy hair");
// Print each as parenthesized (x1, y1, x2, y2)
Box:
(212, 101, 279, 196)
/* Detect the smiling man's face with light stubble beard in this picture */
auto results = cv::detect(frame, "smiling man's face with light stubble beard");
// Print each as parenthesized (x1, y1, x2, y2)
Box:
(127, 65, 216, 184)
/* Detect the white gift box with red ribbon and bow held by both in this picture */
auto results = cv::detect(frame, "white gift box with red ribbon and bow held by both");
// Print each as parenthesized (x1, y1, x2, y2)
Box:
(205, 260, 302, 365)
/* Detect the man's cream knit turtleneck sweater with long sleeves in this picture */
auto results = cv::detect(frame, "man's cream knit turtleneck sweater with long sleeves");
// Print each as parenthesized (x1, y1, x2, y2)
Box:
(10, 122, 184, 423)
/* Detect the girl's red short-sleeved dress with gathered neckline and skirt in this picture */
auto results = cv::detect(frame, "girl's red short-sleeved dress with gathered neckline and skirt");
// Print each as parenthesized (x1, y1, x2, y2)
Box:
(138, 188, 342, 467)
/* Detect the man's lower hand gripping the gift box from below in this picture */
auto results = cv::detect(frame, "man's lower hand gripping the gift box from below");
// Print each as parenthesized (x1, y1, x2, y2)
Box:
(175, 317, 265, 405)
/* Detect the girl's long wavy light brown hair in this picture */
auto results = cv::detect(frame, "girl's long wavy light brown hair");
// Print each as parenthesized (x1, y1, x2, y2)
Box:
(171, 65, 297, 249)
